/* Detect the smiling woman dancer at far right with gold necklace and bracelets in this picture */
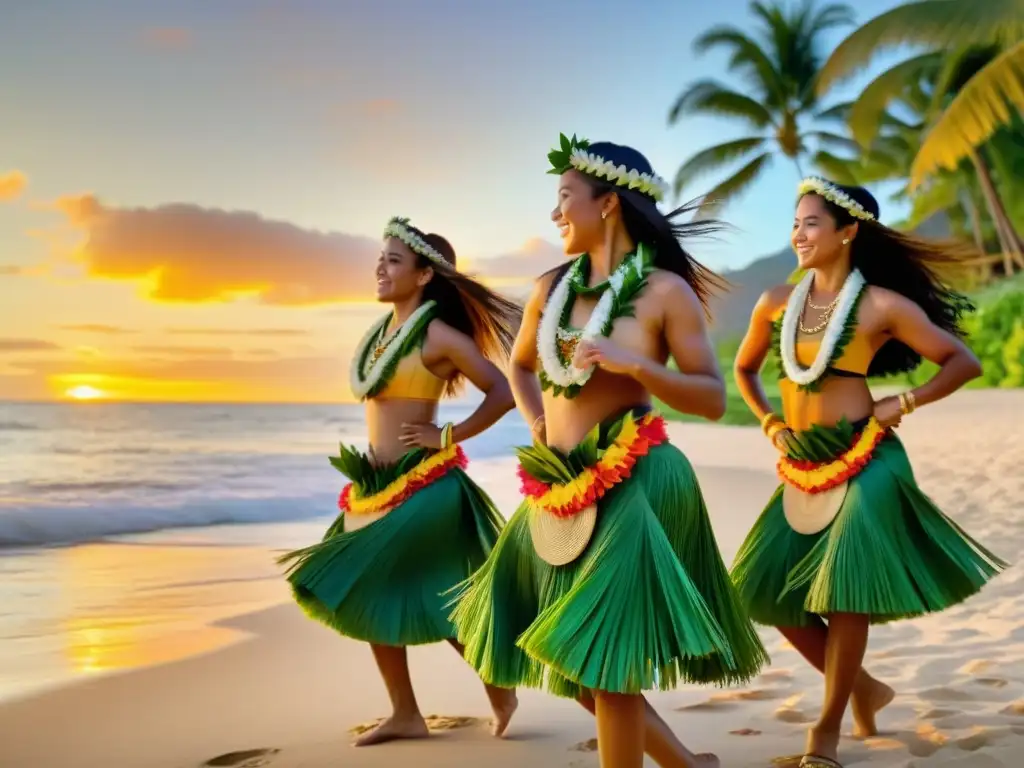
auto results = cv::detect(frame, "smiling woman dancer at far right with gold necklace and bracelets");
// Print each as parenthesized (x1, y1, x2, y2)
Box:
(732, 178, 1005, 768)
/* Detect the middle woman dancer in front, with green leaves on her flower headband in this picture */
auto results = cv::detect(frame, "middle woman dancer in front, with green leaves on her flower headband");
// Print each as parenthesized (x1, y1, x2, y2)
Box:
(453, 136, 766, 768)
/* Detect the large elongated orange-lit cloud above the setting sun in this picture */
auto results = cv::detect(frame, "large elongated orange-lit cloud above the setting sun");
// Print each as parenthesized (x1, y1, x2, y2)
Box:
(54, 195, 380, 306)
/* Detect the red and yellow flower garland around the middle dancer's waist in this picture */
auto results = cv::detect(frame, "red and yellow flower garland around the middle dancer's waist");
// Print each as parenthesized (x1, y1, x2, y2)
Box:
(517, 413, 669, 517)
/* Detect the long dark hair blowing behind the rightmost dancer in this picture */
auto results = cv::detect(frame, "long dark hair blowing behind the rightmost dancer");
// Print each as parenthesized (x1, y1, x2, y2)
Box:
(807, 184, 978, 376)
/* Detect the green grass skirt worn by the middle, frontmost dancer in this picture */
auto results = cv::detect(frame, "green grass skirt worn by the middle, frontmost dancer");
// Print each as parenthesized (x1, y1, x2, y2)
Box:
(452, 415, 767, 697)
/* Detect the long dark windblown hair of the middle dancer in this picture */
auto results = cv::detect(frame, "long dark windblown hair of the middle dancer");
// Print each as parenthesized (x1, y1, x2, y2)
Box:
(551, 141, 728, 317)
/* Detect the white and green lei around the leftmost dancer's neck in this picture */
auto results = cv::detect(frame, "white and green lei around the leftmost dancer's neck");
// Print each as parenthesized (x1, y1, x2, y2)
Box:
(348, 301, 436, 400)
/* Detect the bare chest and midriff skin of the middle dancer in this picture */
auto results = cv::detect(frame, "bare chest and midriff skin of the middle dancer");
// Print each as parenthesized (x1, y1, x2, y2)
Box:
(538, 296, 668, 452)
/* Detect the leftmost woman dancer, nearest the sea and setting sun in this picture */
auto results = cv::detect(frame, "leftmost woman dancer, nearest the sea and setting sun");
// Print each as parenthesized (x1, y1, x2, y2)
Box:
(282, 218, 520, 745)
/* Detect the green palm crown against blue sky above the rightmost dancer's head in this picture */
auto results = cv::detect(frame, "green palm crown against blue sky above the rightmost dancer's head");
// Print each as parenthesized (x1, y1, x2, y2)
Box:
(669, 0, 855, 210)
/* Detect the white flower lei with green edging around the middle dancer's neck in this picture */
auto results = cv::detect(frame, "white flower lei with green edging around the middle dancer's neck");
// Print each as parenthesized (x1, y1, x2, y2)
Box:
(537, 243, 654, 398)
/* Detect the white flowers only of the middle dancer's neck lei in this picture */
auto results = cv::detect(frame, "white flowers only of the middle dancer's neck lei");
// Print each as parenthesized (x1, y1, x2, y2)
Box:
(537, 244, 646, 387)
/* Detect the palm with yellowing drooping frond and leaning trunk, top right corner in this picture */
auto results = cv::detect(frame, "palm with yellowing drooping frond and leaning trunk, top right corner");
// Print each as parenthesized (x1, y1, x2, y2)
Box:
(817, 0, 1024, 272)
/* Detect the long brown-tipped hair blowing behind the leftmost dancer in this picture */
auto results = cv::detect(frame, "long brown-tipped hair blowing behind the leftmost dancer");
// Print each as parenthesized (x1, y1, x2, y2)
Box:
(406, 219, 522, 396)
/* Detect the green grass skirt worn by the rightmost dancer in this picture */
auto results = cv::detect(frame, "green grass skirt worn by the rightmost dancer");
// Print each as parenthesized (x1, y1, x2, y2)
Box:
(732, 425, 1006, 627)
